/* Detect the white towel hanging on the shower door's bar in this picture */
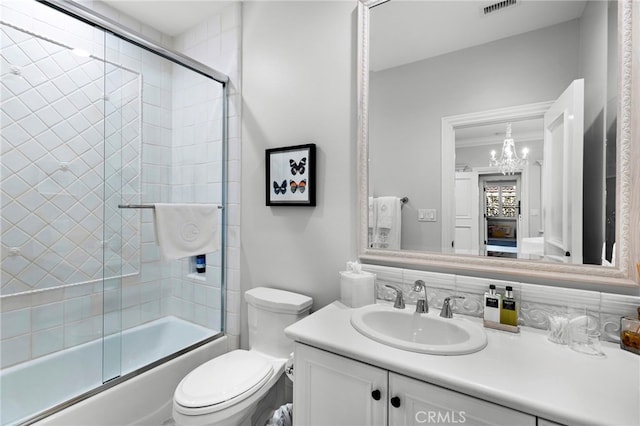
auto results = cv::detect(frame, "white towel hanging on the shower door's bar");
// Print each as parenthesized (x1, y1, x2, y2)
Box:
(154, 203, 219, 260)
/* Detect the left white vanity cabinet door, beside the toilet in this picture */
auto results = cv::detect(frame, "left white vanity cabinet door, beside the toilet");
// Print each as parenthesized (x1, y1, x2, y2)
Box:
(293, 343, 388, 426)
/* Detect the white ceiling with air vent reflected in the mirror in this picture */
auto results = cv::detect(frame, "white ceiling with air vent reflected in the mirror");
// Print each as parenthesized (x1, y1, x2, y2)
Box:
(370, 0, 586, 71)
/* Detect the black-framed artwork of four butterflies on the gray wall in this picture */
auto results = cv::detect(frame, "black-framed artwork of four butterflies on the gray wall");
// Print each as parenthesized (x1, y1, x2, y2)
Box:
(265, 143, 316, 206)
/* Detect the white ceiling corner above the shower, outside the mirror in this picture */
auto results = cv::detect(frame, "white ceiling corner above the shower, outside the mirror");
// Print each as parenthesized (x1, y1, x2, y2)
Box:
(102, 0, 235, 36)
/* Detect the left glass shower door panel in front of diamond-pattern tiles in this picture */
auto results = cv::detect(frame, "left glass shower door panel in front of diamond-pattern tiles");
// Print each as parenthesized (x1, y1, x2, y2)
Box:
(0, 5, 109, 424)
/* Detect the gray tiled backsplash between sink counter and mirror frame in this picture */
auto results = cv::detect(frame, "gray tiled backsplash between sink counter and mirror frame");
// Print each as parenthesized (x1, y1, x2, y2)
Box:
(362, 265, 640, 343)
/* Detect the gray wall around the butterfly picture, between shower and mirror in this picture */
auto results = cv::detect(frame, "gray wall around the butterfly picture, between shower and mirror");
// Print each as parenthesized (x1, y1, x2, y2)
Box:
(240, 1, 357, 347)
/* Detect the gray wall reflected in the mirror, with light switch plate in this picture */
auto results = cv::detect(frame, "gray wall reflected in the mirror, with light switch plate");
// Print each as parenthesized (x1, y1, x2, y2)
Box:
(370, 20, 580, 251)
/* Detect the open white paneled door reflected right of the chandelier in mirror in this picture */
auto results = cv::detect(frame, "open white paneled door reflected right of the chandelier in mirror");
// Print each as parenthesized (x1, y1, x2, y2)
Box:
(542, 79, 584, 264)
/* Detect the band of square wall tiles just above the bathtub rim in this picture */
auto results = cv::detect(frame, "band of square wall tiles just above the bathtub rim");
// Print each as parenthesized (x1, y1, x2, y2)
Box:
(0, 272, 221, 368)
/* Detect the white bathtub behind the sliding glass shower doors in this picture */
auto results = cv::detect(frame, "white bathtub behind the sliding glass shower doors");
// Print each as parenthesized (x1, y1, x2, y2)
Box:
(0, 317, 227, 426)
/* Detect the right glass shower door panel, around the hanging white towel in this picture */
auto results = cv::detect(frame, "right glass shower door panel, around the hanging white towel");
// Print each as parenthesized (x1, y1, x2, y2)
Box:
(104, 33, 226, 381)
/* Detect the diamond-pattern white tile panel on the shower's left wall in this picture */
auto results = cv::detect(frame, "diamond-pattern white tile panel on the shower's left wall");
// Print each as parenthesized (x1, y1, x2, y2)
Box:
(0, 24, 142, 295)
